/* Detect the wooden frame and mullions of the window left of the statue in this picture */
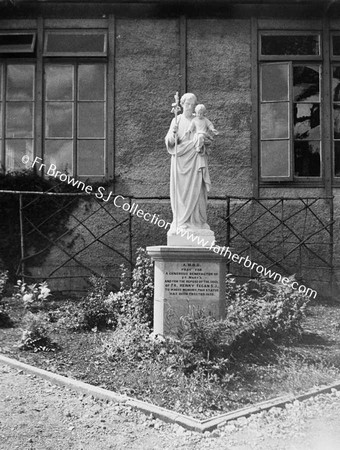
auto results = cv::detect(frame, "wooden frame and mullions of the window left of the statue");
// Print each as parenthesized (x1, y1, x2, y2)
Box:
(0, 20, 110, 179)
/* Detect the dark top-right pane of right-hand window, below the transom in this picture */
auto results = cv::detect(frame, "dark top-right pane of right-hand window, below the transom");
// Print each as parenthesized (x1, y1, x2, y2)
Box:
(293, 66, 320, 102)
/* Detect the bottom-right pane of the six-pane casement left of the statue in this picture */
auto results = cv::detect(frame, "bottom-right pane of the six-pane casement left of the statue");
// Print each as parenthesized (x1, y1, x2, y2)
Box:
(78, 140, 105, 176)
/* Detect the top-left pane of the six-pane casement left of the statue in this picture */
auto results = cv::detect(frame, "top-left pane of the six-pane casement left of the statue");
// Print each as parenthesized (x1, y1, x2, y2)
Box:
(45, 65, 73, 100)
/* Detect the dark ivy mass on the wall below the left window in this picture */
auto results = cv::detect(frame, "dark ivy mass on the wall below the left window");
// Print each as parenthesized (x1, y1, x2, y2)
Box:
(0, 171, 82, 281)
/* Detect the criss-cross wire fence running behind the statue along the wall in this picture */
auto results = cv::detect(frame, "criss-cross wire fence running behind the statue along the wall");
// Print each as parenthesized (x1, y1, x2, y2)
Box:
(0, 191, 335, 298)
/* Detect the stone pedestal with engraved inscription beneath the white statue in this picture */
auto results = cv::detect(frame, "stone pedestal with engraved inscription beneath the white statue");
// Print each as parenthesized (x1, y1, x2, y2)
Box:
(146, 245, 226, 335)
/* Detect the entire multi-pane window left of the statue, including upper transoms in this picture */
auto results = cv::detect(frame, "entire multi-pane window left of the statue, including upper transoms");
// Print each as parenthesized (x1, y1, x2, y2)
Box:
(0, 29, 107, 178)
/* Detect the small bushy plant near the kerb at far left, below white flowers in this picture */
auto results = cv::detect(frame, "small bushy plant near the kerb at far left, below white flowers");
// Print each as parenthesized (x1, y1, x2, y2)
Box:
(19, 313, 58, 352)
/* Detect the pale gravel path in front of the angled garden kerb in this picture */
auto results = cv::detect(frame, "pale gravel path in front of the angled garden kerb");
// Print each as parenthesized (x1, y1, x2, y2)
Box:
(0, 364, 340, 450)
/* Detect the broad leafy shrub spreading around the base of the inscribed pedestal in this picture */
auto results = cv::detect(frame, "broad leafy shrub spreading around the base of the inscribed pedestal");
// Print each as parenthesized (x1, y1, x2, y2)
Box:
(104, 276, 308, 379)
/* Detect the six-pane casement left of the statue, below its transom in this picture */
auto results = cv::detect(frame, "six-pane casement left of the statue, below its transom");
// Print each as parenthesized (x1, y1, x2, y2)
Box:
(44, 63, 106, 176)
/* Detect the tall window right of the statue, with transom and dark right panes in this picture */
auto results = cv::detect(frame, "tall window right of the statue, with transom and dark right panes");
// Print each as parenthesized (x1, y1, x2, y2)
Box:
(259, 32, 322, 181)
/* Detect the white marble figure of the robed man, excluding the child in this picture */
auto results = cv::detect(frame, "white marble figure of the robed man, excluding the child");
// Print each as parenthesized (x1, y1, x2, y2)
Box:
(165, 93, 214, 245)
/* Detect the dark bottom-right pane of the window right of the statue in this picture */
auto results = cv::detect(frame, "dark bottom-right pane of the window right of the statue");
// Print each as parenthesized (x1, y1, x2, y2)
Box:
(294, 141, 321, 177)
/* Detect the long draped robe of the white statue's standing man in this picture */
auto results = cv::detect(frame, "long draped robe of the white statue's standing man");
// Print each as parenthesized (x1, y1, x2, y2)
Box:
(165, 114, 211, 232)
